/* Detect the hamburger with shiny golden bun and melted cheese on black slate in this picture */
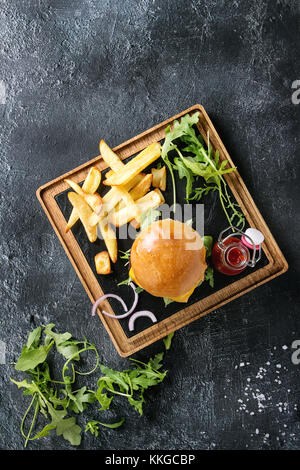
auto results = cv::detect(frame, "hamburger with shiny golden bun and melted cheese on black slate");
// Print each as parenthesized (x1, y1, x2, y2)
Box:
(129, 219, 207, 302)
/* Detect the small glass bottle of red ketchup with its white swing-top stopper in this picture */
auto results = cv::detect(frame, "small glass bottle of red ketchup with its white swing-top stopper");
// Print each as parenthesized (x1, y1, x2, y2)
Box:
(212, 227, 264, 276)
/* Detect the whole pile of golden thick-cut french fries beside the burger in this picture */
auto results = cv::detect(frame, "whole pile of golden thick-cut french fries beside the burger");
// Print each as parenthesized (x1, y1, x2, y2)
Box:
(65, 140, 166, 274)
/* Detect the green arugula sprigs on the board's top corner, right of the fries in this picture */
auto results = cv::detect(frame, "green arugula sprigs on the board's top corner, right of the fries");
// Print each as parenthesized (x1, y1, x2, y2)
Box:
(161, 113, 245, 229)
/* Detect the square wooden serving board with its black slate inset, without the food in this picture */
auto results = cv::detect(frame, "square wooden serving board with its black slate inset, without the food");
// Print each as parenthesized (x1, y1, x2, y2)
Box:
(37, 104, 288, 357)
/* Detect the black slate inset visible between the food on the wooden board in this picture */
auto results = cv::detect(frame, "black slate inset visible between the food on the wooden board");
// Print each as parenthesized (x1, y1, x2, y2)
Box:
(55, 136, 269, 338)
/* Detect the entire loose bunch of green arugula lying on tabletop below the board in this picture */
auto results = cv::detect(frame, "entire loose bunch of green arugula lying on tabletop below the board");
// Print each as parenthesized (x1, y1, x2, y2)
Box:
(10, 323, 171, 447)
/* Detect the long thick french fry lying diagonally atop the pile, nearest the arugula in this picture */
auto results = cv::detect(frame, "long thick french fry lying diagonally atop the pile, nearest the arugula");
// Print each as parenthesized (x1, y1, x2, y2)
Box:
(103, 142, 161, 186)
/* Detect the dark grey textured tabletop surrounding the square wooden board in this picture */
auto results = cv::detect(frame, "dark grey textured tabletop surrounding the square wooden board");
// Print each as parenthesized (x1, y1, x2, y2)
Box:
(0, 0, 300, 449)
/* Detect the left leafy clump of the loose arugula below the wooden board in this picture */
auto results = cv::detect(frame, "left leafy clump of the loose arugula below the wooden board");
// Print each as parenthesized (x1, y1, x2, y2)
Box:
(10, 324, 99, 447)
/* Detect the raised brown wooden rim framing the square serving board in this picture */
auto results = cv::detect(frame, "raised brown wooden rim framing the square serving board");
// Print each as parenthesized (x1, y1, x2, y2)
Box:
(36, 104, 288, 357)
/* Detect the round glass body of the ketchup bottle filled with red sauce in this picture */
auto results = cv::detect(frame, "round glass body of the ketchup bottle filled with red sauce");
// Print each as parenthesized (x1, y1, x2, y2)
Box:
(212, 237, 250, 276)
